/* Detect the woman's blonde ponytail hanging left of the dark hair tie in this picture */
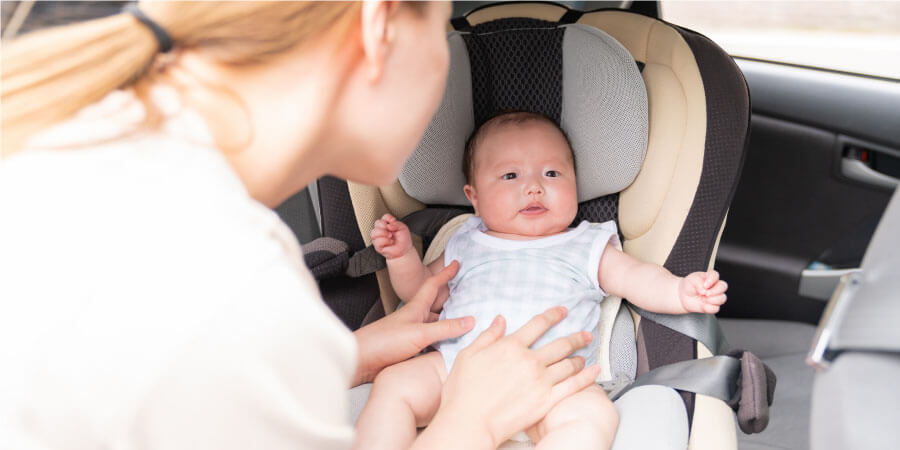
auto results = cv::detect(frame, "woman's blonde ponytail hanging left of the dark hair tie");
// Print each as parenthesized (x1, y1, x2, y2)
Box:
(0, 14, 159, 156)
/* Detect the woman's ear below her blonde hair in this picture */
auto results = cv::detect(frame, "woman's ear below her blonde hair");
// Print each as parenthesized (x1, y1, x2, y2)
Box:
(360, 0, 396, 82)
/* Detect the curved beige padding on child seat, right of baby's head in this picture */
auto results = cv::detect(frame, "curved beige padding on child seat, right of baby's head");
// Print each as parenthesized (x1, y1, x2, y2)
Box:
(578, 11, 706, 264)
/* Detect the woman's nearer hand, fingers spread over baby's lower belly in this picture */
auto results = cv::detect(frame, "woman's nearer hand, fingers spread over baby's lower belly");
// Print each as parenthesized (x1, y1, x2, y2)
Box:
(414, 307, 600, 448)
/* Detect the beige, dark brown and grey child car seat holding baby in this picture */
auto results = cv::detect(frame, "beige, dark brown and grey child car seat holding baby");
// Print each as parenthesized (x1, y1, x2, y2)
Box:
(304, 3, 774, 449)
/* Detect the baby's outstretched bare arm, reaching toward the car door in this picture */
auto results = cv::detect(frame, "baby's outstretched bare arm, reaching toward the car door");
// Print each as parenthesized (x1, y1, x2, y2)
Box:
(597, 244, 728, 314)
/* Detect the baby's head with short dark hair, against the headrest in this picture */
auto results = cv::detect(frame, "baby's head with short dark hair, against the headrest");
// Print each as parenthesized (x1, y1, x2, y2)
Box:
(465, 121, 578, 238)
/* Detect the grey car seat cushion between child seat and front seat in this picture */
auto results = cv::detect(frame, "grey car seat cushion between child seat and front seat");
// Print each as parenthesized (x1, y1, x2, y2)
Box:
(719, 319, 820, 450)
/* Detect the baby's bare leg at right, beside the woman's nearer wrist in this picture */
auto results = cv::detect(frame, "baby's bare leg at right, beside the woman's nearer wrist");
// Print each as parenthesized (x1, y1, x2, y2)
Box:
(527, 384, 619, 450)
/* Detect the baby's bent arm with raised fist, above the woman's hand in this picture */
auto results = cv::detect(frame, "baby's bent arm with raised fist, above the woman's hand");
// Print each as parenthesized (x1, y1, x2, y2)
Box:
(371, 214, 446, 304)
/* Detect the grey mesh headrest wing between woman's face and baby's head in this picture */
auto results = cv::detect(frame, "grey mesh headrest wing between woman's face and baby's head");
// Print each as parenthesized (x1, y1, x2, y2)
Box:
(400, 31, 475, 205)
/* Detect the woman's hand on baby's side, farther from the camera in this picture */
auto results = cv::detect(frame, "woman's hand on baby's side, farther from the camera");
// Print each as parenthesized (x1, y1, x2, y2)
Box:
(353, 261, 475, 386)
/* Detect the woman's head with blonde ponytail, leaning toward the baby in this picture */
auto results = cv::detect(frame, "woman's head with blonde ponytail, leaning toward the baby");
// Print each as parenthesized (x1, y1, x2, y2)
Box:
(2, 0, 449, 202)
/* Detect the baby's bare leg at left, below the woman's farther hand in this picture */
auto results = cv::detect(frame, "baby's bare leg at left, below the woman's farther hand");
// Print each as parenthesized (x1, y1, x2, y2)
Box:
(354, 352, 447, 449)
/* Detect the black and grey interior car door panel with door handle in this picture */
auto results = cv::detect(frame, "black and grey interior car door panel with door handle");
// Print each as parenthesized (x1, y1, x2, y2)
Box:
(716, 60, 900, 323)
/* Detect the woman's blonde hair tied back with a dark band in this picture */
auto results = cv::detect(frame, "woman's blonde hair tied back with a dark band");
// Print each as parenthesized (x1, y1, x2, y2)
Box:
(0, 1, 370, 156)
